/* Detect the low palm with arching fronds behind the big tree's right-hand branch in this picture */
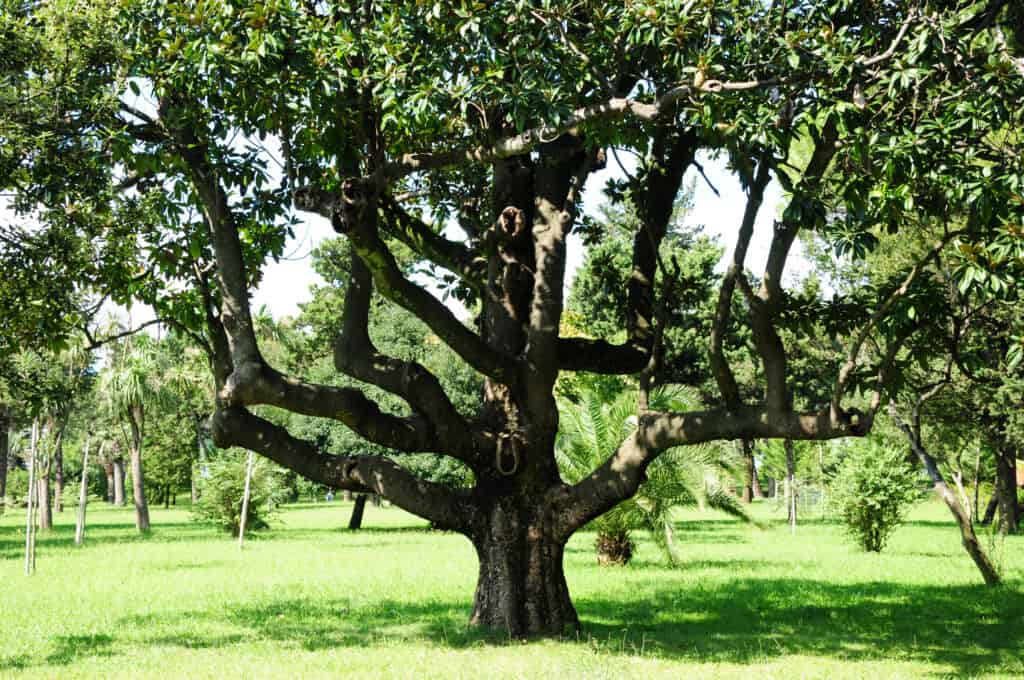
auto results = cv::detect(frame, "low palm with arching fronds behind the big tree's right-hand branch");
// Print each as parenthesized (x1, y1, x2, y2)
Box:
(556, 385, 751, 564)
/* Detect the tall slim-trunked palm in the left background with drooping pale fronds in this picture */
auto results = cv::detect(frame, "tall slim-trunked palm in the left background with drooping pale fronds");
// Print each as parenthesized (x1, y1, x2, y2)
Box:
(99, 336, 168, 533)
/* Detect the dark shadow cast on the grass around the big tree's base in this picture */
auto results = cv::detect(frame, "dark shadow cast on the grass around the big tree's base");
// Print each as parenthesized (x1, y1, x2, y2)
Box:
(0, 577, 999, 675)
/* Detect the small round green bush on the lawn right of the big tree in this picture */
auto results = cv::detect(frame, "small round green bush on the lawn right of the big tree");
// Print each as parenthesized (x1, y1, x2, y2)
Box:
(829, 441, 922, 552)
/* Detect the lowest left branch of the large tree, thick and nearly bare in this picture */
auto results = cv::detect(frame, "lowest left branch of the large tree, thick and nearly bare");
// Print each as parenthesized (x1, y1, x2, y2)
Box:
(211, 408, 476, 533)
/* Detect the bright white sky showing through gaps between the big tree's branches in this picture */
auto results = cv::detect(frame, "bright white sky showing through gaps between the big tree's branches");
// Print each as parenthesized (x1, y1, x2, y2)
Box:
(252, 152, 807, 318)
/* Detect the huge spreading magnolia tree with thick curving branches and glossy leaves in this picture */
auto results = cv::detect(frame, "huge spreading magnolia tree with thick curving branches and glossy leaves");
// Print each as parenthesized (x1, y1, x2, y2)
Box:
(0, 0, 1024, 634)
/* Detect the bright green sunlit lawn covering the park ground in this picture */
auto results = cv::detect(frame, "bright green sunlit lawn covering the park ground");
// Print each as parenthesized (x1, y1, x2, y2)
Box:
(0, 502, 1024, 678)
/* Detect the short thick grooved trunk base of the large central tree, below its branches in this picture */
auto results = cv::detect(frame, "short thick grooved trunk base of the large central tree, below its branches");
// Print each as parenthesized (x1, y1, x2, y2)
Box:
(470, 498, 580, 636)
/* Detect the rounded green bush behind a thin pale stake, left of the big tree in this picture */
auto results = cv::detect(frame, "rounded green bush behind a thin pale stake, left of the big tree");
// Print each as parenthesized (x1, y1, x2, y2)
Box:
(193, 452, 286, 536)
